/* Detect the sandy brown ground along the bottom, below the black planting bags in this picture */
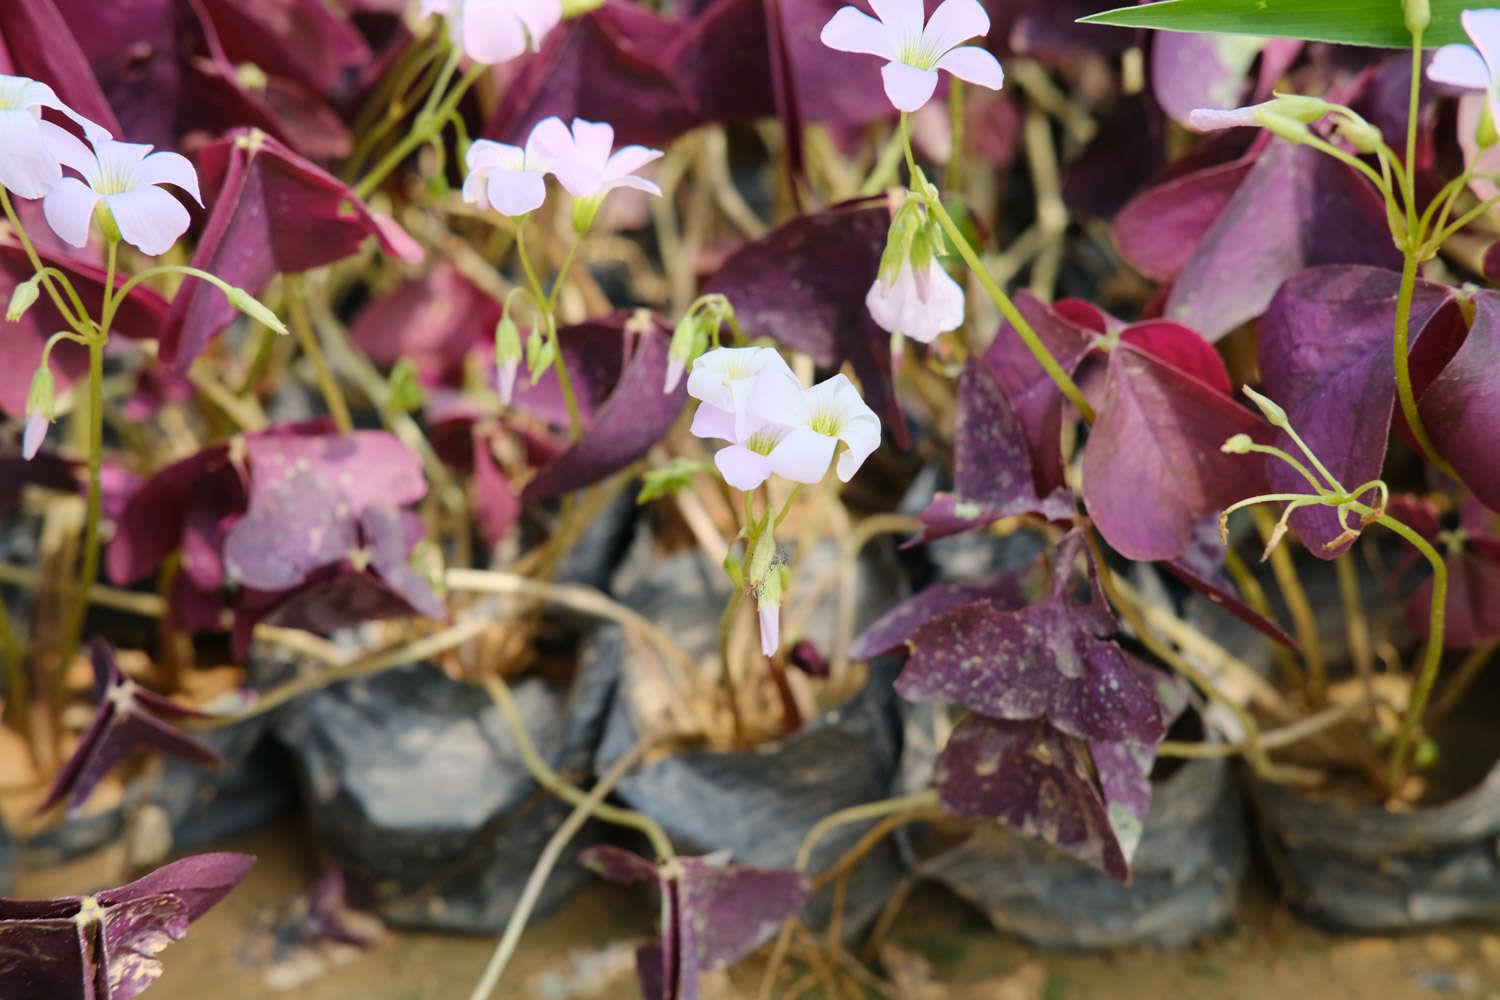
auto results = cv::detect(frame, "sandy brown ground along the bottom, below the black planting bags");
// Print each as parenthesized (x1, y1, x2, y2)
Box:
(52, 825, 1500, 1000)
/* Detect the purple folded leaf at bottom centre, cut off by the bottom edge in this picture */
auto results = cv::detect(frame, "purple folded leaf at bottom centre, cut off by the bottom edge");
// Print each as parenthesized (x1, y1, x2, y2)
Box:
(579, 844, 812, 1000)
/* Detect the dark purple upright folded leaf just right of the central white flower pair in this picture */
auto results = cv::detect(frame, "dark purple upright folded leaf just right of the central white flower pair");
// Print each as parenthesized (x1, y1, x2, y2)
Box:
(908, 364, 1077, 544)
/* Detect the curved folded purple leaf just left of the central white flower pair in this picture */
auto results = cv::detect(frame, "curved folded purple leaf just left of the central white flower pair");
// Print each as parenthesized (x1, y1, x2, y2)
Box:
(522, 316, 687, 499)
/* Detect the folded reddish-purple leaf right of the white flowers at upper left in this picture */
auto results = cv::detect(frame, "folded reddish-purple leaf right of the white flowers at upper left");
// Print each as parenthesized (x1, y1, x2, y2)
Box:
(161, 130, 422, 370)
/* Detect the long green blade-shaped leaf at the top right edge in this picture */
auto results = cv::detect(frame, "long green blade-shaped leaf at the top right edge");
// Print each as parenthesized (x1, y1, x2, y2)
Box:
(1079, 0, 1485, 48)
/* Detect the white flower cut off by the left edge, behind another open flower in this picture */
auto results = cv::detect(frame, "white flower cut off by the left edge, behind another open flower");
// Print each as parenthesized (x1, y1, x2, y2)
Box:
(0, 73, 110, 198)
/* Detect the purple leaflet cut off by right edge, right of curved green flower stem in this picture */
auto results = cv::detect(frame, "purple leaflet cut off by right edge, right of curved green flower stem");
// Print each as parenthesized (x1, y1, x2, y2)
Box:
(1418, 292, 1500, 511)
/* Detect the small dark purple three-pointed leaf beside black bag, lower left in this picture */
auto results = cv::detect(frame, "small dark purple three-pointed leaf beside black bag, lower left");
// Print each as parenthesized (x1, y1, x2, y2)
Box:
(38, 639, 224, 813)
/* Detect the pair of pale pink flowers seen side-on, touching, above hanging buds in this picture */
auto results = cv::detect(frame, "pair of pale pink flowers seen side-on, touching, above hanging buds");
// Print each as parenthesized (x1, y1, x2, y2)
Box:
(464, 115, 662, 232)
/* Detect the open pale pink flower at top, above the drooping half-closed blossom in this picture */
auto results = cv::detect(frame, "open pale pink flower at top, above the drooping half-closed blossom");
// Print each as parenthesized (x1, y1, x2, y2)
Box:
(821, 0, 1005, 111)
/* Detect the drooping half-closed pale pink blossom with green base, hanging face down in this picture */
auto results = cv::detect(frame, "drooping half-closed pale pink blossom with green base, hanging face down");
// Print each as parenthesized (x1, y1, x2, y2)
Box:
(864, 198, 965, 357)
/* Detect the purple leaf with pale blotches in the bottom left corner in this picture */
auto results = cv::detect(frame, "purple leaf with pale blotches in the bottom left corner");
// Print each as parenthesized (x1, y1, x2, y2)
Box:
(0, 853, 255, 1000)
